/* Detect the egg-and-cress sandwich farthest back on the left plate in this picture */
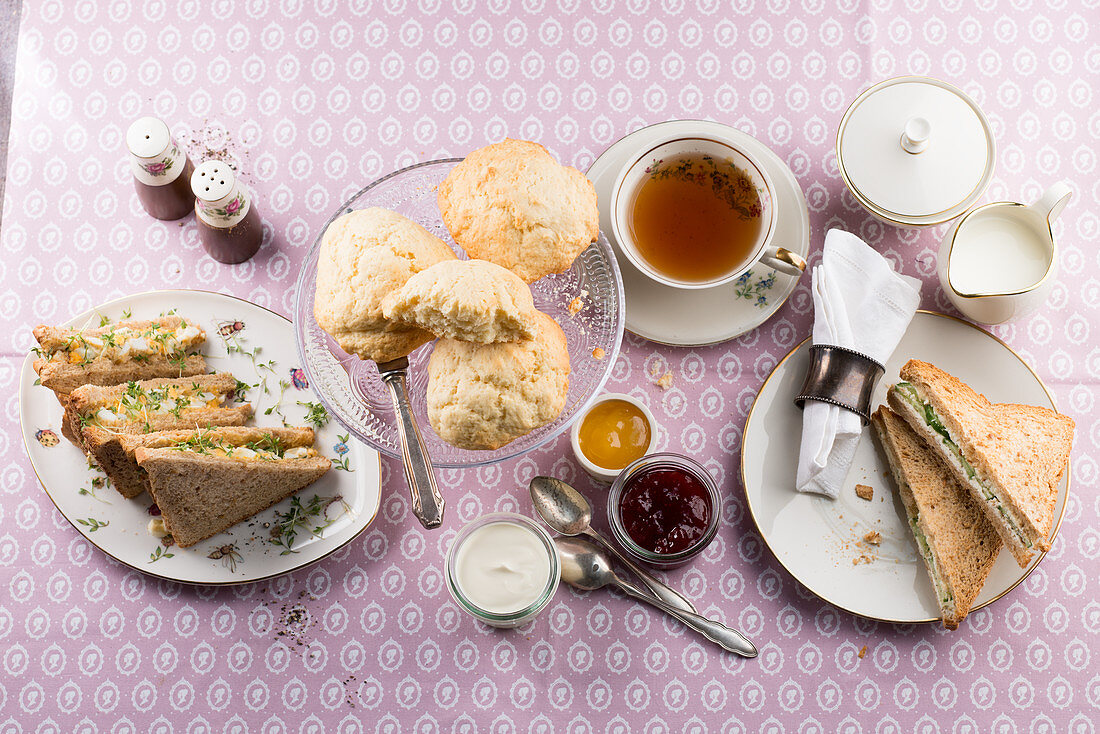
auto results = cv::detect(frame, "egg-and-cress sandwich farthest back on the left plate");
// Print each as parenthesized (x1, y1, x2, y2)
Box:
(33, 316, 206, 403)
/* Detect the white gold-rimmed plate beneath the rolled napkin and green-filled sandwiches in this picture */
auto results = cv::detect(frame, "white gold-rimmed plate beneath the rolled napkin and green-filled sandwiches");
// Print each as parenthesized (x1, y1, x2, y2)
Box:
(741, 311, 1070, 623)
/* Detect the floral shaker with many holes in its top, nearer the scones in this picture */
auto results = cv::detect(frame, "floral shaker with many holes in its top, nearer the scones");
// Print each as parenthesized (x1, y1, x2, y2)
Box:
(191, 161, 264, 264)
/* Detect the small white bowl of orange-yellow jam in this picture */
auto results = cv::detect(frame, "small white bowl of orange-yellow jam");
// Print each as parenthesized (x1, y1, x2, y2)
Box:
(570, 393, 657, 484)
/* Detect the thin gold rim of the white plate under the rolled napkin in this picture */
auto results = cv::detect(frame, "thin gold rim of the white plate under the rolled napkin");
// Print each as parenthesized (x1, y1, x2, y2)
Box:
(738, 309, 1073, 624)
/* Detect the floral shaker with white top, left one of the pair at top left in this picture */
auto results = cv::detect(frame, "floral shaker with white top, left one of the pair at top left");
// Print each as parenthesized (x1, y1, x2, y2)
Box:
(127, 117, 195, 219)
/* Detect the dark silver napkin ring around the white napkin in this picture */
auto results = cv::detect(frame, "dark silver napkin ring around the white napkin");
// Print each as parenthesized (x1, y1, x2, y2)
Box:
(794, 344, 886, 426)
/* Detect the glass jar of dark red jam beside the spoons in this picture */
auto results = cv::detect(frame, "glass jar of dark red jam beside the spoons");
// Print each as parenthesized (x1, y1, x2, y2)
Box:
(607, 453, 722, 568)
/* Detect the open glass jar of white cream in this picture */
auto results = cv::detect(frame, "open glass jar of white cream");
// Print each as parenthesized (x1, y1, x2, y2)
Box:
(446, 513, 561, 627)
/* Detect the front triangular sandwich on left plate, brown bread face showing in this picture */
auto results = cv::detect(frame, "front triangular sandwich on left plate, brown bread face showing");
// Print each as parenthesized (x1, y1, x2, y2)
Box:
(120, 426, 332, 547)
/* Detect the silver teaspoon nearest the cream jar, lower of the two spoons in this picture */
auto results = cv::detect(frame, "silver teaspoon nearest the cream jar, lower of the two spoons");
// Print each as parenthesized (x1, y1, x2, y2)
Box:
(553, 537, 757, 658)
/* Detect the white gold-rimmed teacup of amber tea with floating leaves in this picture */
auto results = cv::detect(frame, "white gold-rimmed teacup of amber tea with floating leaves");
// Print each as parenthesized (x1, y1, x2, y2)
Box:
(612, 136, 806, 288)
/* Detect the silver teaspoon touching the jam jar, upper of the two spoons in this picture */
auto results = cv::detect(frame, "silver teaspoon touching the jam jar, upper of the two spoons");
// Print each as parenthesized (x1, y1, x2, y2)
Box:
(530, 476, 697, 613)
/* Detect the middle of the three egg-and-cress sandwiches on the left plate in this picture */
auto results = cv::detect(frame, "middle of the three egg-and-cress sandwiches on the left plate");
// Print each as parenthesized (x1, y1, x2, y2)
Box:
(69, 372, 252, 499)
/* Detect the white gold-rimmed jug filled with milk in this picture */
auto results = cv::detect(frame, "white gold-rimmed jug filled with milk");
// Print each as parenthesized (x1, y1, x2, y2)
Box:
(938, 183, 1073, 324)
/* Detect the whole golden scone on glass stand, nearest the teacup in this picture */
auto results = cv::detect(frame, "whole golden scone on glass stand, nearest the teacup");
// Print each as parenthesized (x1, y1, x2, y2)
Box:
(439, 140, 600, 283)
